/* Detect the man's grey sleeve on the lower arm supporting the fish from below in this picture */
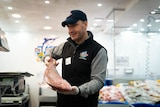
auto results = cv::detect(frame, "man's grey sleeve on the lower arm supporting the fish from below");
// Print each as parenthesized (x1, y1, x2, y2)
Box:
(79, 48, 108, 97)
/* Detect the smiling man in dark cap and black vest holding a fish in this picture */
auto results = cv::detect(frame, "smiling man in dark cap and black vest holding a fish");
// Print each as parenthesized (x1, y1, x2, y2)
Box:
(44, 10, 108, 107)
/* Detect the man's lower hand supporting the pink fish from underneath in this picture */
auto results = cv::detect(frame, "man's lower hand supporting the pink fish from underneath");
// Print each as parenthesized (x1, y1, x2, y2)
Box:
(57, 86, 80, 95)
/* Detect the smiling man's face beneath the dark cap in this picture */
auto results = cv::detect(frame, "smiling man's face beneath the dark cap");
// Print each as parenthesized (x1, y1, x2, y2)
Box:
(67, 20, 87, 43)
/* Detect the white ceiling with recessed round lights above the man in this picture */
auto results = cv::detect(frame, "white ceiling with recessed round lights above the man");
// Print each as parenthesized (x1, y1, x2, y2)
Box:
(0, 0, 160, 33)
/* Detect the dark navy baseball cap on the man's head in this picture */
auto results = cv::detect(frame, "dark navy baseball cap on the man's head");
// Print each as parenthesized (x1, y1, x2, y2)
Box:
(62, 10, 87, 27)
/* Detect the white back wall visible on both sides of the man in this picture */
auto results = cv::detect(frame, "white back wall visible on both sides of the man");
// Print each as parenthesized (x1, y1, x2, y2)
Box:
(0, 32, 160, 107)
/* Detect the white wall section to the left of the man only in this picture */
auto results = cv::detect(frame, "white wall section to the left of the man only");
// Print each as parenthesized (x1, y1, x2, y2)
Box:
(0, 33, 67, 107)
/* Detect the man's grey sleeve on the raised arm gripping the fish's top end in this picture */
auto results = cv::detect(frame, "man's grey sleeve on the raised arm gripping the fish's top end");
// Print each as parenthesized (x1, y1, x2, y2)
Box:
(43, 42, 65, 62)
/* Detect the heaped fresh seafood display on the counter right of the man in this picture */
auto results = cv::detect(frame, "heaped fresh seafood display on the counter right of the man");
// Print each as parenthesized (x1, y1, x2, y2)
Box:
(99, 80, 160, 107)
